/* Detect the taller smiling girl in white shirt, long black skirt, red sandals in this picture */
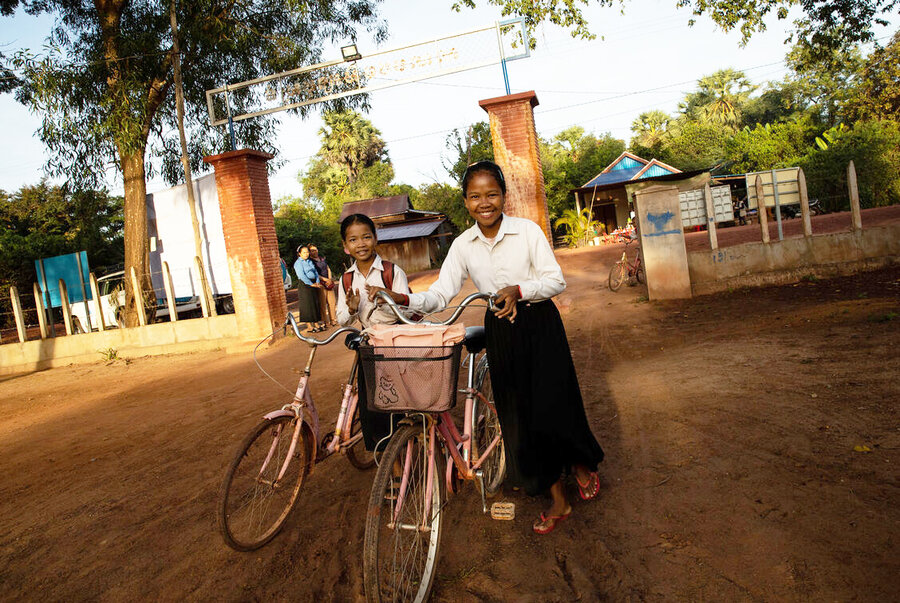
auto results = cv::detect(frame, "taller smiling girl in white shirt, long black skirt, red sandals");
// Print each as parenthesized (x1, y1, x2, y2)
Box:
(369, 161, 603, 534)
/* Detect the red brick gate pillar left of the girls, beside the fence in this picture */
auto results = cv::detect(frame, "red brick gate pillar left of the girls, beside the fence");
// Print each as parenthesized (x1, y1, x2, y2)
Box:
(203, 149, 287, 339)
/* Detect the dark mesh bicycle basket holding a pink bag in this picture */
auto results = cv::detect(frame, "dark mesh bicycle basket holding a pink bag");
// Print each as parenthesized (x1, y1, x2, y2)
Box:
(359, 344, 462, 413)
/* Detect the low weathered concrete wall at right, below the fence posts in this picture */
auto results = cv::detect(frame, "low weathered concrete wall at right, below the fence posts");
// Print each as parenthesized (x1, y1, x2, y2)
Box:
(688, 224, 900, 295)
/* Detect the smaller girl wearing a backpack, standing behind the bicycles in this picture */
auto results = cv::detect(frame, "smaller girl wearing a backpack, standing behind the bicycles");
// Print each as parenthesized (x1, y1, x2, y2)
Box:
(337, 214, 409, 451)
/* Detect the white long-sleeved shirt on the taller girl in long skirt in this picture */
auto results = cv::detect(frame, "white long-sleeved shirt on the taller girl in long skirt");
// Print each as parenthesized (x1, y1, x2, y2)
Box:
(412, 214, 566, 313)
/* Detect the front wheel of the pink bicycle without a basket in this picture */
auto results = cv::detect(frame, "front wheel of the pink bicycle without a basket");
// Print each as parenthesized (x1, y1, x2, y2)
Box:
(218, 417, 307, 551)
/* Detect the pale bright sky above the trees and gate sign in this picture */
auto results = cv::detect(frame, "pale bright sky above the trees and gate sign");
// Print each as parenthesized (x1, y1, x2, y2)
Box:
(0, 0, 893, 201)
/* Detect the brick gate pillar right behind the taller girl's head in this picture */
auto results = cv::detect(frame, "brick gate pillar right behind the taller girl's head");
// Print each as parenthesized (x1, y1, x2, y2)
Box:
(478, 91, 553, 245)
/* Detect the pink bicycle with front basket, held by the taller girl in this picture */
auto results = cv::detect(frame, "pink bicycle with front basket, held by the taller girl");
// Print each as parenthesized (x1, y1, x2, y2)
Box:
(360, 293, 511, 602)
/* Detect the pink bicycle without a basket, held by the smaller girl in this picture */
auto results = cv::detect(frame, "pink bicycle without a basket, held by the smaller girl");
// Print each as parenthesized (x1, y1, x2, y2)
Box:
(217, 313, 375, 551)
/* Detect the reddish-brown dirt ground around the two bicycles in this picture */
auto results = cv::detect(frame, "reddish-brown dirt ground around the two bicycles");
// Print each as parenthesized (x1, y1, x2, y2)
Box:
(0, 246, 900, 601)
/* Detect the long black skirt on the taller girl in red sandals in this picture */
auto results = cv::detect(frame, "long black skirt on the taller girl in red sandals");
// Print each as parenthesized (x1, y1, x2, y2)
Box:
(484, 300, 603, 496)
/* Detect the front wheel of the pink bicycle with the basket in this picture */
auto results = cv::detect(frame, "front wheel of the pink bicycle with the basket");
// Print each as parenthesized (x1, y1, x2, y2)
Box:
(363, 425, 444, 603)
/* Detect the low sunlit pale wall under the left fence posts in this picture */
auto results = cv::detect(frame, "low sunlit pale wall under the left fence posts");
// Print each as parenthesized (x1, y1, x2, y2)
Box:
(0, 314, 244, 374)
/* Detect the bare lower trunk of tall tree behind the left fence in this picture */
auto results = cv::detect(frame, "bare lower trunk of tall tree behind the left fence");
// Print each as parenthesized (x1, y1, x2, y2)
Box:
(119, 147, 156, 327)
